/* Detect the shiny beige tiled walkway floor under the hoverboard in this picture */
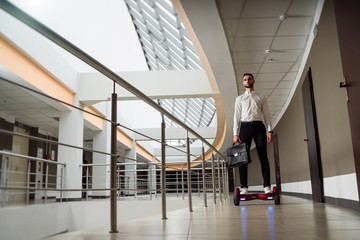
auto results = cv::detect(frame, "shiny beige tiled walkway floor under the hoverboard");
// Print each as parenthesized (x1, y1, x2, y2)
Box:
(47, 196, 360, 240)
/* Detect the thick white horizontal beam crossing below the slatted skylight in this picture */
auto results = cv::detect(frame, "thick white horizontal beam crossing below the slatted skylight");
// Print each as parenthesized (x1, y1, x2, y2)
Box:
(78, 70, 219, 105)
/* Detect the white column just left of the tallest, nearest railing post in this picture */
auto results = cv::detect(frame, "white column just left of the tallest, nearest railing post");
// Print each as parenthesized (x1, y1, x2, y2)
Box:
(92, 103, 111, 198)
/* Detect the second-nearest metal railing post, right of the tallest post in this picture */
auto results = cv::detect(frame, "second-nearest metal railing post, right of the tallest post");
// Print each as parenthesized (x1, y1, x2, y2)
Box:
(161, 114, 167, 219)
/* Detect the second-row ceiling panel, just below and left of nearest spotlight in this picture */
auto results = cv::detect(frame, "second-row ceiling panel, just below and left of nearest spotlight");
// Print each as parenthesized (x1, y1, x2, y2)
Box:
(236, 18, 280, 37)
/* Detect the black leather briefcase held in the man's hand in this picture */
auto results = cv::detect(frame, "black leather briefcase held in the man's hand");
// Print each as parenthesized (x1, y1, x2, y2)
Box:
(226, 142, 250, 168)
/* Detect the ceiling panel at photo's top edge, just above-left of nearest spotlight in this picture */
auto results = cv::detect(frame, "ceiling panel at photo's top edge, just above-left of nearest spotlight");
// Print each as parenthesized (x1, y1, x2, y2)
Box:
(243, 0, 291, 17)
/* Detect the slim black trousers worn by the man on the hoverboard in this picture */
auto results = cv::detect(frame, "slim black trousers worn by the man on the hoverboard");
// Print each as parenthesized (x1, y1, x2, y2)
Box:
(239, 121, 270, 187)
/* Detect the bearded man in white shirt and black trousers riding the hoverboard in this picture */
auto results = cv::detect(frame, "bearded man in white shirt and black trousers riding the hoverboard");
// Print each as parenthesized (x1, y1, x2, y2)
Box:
(234, 73, 273, 195)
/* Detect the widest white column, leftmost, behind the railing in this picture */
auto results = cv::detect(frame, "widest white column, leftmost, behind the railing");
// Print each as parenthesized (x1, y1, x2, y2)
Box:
(57, 96, 84, 200)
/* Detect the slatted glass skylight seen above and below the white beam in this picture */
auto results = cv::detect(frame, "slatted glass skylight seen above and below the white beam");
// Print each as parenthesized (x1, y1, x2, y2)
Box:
(125, 0, 216, 127)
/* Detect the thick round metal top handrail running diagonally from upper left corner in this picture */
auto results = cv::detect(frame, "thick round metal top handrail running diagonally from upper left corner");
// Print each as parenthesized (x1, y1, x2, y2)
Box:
(0, 1, 225, 159)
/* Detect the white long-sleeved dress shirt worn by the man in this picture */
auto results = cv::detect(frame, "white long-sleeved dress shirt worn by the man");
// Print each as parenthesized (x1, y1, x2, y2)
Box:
(233, 91, 272, 135)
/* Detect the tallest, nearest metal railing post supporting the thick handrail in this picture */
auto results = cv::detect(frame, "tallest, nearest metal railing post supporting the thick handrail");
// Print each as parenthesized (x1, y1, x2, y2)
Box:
(110, 90, 118, 233)
